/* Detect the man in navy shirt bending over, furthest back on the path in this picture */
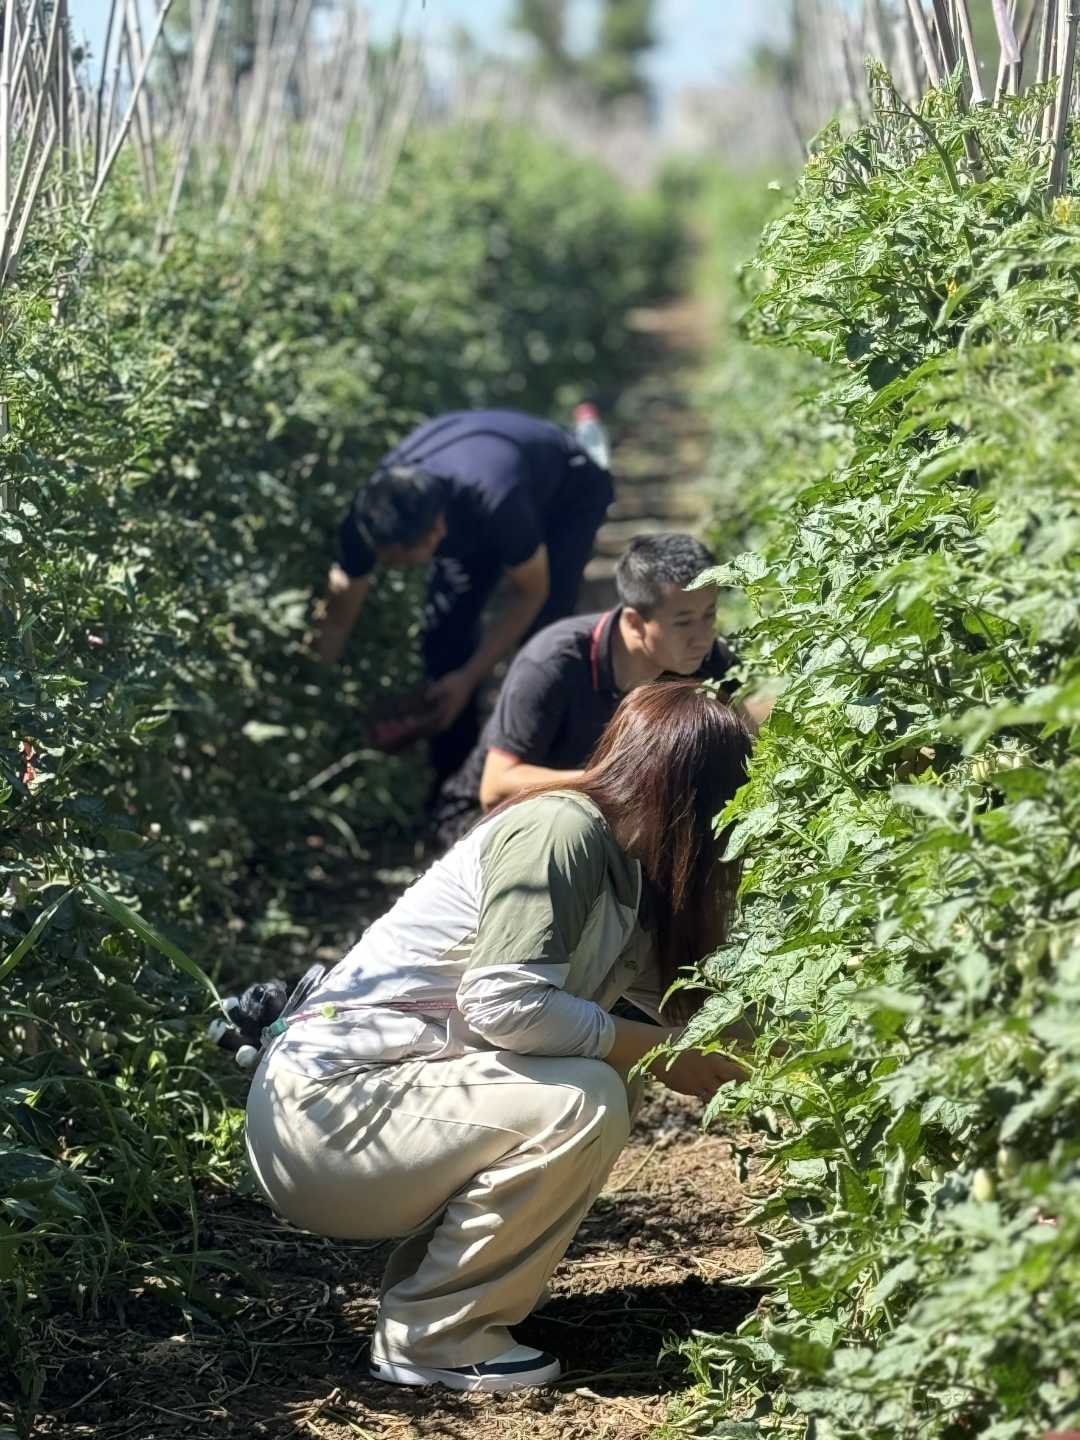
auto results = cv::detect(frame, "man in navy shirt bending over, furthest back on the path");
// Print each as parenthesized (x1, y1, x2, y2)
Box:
(320, 410, 613, 778)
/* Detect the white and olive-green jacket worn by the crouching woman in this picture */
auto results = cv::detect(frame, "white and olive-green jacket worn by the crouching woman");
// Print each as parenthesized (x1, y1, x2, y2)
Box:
(268, 791, 660, 1076)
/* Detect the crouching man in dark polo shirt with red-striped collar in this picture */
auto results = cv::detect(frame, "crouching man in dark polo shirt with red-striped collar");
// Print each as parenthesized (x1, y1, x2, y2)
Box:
(435, 534, 736, 845)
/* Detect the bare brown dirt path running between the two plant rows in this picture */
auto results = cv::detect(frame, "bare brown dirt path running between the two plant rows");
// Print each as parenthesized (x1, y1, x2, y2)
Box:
(27, 307, 759, 1440)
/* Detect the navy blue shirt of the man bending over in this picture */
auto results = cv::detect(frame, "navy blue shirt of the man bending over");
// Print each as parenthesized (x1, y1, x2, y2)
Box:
(340, 410, 589, 579)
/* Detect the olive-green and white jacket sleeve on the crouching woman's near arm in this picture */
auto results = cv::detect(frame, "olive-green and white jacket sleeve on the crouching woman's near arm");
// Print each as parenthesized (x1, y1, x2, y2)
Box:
(458, 795, 615, 1058)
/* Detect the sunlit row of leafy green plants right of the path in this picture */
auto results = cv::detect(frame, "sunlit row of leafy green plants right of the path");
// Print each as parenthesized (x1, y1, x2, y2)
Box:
(680, 72, 1080, 1440)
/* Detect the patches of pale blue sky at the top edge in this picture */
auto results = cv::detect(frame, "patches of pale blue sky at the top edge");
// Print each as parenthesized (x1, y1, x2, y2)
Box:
(71, 0, 783, 104)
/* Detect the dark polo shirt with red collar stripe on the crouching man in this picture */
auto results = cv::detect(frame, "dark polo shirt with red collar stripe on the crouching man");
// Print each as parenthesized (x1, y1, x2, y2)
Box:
(435, 609, 736, 845)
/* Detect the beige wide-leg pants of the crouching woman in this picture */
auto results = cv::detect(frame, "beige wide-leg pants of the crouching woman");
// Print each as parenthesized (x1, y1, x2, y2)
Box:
(248, 1051, 638, 1367)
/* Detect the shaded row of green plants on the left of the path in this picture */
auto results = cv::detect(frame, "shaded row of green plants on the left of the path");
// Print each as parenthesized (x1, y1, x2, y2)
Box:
(0, 128, 674, 1426)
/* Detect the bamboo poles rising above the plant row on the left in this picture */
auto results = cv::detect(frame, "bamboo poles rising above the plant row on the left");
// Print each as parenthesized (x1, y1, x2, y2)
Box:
(0, 0, 426, 291)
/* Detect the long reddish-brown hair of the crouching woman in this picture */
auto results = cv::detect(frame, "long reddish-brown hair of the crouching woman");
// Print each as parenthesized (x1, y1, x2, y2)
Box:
(521, 680, 753, 1012)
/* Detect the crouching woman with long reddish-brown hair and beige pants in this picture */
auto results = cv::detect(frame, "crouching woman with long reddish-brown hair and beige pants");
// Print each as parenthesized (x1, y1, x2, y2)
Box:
(248, 681, 750, 1391)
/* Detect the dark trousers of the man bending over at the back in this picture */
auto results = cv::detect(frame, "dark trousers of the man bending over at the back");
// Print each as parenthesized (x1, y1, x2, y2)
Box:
(423, 459, 615, 789)
